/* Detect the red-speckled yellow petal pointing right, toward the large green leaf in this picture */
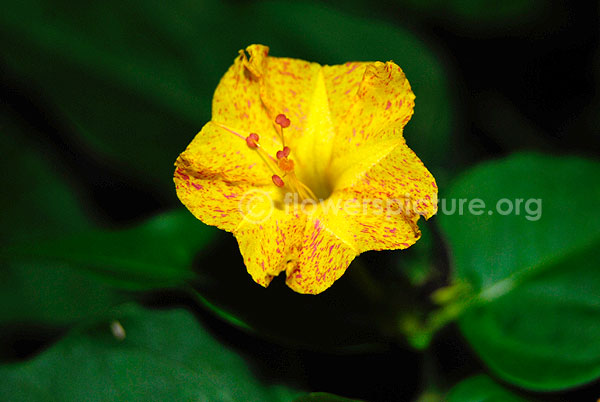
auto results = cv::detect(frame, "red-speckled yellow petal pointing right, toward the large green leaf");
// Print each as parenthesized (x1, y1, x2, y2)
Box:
(326, 140, 437, 253)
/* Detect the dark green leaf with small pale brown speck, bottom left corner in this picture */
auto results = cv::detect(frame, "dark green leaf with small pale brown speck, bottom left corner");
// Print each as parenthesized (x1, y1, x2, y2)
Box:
(0, 305, 297, 401)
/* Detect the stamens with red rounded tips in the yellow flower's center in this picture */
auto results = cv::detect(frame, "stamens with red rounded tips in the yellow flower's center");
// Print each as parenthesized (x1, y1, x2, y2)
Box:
(246, 114, 317, 201)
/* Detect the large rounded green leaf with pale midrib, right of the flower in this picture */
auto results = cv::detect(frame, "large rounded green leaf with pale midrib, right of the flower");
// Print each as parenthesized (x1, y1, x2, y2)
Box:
(438, 154, 600, 390)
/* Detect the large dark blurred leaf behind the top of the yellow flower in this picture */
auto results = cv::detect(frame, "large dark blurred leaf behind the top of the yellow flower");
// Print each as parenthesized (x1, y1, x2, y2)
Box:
(0, 0, 452, 196)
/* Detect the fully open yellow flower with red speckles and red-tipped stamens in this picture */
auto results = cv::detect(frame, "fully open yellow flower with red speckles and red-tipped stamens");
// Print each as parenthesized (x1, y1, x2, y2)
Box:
(174, 45, 437, 294)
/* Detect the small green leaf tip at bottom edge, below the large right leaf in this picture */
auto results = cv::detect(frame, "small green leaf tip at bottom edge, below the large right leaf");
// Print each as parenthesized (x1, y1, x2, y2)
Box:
(446, 374, 527, 402)
